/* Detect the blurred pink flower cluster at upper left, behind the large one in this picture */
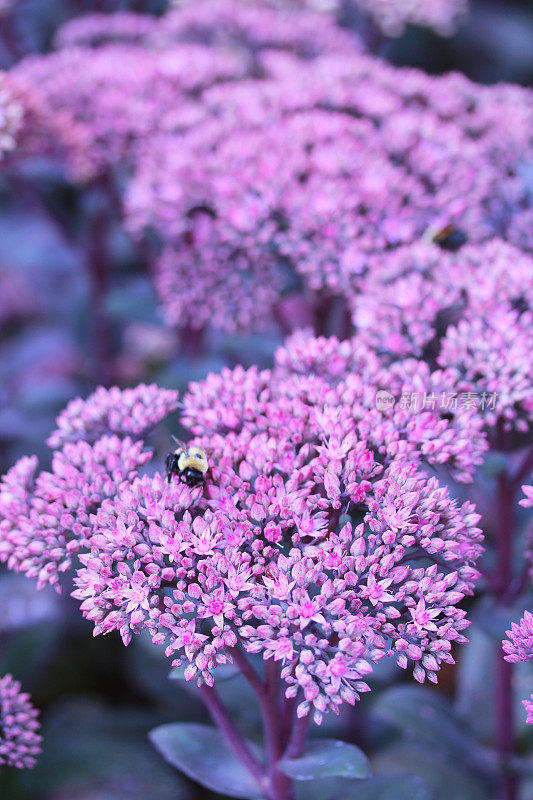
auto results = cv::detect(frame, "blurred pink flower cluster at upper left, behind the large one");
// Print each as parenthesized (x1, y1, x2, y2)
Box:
(9, 42, 243, 181)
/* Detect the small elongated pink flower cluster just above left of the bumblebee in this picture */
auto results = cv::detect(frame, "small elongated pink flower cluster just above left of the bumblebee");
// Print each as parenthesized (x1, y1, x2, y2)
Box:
(47, 383, 178, 448)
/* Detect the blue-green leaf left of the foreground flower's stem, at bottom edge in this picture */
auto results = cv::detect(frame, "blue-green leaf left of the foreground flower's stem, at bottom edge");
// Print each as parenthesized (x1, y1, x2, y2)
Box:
(149, 722, 262, 800)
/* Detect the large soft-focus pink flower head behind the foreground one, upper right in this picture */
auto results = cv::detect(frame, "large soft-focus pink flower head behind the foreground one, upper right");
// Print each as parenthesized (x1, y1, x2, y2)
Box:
(125, 46, 533, 340)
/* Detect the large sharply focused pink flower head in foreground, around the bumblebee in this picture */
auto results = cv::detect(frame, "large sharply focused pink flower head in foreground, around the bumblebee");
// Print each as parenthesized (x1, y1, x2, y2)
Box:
(0, 334, 485, 722)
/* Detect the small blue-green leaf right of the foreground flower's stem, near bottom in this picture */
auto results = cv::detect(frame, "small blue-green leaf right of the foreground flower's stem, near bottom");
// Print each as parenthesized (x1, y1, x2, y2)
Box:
(279, 739, 369, 781)
